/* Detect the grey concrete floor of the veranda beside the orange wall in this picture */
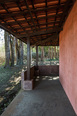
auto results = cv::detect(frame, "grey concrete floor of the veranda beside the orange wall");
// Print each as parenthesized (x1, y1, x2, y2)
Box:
(1, 77, 76, 116)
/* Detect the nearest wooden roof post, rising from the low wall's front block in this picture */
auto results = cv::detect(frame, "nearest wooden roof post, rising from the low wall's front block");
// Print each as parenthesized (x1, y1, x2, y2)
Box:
(27, 37, 31, 80)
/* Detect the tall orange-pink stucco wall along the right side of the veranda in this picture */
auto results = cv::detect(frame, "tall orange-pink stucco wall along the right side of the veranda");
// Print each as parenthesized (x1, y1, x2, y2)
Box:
(59, 1, 77, 114)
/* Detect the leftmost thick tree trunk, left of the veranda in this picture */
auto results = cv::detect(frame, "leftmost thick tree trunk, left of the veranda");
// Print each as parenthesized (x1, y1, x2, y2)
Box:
(4, 31, 10, 68)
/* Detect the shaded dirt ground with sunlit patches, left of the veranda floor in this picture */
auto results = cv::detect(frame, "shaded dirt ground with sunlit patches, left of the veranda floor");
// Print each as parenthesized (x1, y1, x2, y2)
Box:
(0, 66, 26, 114)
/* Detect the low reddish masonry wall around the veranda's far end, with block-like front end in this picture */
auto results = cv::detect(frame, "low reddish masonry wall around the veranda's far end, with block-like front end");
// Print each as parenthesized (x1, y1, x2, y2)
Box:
(21, 65, 59, 90)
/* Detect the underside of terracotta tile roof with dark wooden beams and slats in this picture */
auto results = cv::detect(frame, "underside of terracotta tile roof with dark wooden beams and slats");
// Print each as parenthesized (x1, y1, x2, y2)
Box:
(0, 0, 76, 45)
